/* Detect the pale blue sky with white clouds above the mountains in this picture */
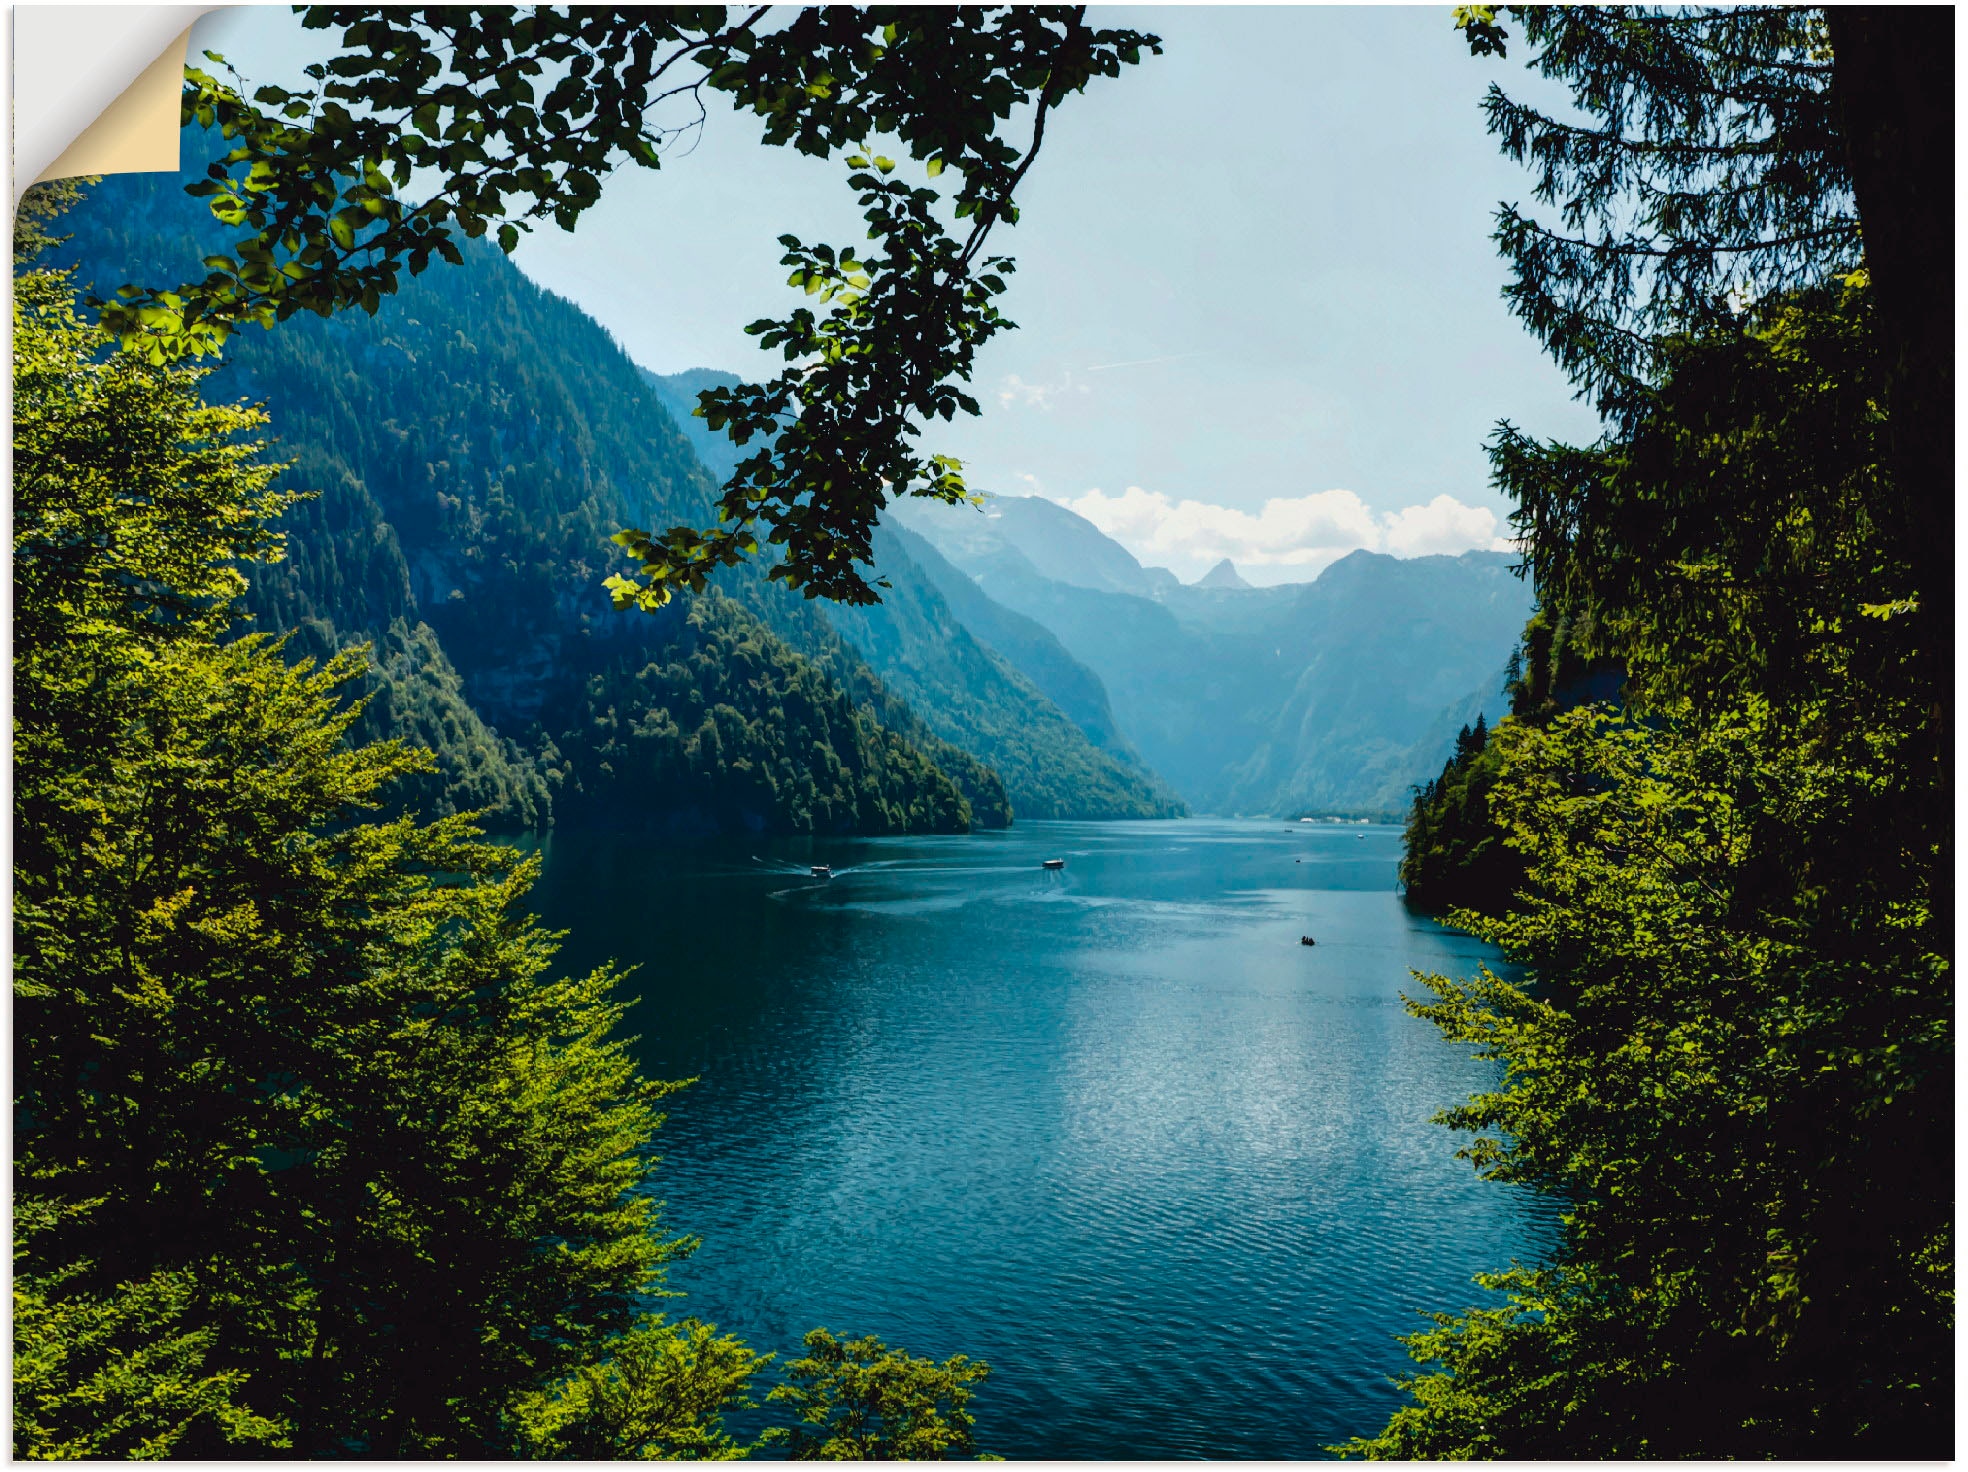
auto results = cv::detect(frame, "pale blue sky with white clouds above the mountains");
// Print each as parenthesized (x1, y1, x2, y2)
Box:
(181, 6, 1596, 583)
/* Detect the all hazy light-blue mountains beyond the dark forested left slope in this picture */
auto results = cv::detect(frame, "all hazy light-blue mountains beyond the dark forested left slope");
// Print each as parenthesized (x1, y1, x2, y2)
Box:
(647, 368, 1531, 819)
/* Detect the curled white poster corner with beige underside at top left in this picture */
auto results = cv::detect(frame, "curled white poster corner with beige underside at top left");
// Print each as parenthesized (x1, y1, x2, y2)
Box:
(14, 6, 211, 205)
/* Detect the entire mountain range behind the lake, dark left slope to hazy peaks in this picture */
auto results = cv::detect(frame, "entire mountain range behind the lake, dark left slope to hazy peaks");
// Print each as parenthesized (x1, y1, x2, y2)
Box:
(63, 152, 1529, 832)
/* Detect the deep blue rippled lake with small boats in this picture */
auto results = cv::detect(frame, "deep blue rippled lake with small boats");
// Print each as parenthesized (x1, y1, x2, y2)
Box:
(535, 819, 1555, 1458)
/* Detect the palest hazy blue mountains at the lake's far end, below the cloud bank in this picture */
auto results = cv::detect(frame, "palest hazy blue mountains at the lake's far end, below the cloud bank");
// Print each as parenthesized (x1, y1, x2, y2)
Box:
(895, 498, 1531, 817)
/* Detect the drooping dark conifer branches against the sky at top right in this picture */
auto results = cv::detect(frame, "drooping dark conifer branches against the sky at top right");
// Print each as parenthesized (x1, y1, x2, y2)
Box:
(1456, 6, 1860, 423)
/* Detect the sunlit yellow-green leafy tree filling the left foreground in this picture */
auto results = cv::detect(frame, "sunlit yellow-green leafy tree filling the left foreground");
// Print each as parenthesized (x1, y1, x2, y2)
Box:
(14, 249, 758, 1456)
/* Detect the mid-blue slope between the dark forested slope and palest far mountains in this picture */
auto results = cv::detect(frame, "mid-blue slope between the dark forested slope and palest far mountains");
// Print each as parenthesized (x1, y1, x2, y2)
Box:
(644, 368, 1185, 819)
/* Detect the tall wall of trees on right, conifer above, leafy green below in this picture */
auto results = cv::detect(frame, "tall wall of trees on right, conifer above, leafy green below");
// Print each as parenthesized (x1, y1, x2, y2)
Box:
(1348, 10, 1952, 1456)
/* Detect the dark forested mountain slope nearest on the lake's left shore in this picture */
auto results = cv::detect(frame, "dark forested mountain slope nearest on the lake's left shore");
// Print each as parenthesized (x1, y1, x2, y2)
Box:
(57, 158, 984, 832)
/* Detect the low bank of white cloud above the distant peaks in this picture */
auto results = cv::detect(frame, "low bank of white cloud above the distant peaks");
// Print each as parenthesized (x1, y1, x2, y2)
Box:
(1055, 486, 1511, 583)
